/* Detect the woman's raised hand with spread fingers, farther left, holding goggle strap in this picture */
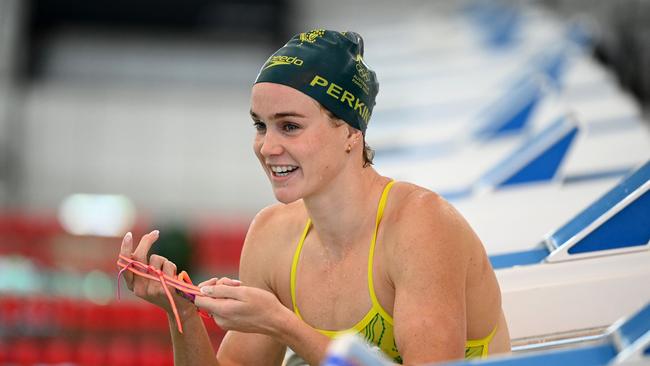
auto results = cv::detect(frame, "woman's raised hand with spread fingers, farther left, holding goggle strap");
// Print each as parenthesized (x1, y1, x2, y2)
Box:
(120, 230, 195, 316)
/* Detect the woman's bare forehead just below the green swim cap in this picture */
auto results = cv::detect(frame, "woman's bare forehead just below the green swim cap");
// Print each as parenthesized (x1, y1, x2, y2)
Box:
(251, 83, 320, 116)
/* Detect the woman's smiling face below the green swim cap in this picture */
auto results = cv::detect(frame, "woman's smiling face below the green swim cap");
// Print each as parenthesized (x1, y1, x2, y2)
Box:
(251, 83, 350, 203)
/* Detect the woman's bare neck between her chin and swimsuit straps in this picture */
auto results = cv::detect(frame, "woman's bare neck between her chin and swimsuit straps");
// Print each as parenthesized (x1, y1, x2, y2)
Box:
(303, 167, 388, 257)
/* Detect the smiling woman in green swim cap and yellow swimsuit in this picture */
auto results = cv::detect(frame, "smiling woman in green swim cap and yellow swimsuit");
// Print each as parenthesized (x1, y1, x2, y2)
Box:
(121, 30, 510, 365)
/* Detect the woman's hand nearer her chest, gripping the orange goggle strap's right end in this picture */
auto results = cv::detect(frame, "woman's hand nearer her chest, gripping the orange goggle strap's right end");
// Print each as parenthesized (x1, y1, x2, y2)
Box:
(194, 278, 292, 335)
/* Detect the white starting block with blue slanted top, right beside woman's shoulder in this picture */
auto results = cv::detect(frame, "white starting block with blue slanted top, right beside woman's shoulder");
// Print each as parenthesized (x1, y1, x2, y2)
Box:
(491, 161, 650, 340)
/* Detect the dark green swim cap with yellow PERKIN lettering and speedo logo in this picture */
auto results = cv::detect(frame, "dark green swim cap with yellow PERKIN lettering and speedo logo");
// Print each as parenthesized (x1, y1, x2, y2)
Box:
(255, 29, 379, 134)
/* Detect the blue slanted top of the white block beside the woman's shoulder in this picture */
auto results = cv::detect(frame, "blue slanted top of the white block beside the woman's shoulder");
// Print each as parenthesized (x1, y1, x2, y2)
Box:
(490, 161, 650, 269)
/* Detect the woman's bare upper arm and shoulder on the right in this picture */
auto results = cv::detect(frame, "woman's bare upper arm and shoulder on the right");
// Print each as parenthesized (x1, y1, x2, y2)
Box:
(388, 190, 478, 364)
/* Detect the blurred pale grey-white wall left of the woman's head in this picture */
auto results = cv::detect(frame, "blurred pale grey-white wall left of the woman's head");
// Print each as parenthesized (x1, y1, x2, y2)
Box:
(20, 36, 274, 217)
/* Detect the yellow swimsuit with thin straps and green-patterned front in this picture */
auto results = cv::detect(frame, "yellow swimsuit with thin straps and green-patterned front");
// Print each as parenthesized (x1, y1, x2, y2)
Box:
(291, 181, 496, 363)
